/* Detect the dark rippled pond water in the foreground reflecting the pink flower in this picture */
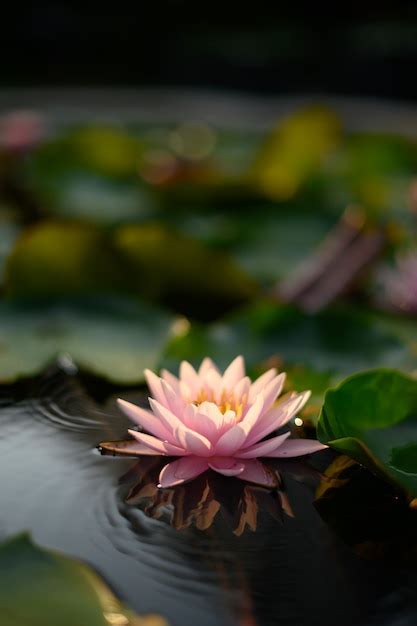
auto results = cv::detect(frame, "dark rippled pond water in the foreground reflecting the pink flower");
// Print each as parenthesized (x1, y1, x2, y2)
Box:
(0, 369, 417, 626)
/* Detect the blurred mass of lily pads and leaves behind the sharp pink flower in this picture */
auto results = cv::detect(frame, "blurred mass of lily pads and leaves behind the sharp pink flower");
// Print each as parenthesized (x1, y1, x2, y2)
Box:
(0, 104, 417, 400)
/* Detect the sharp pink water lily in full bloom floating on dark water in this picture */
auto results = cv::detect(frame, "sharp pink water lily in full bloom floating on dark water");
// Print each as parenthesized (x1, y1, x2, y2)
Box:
(119, 356, 326, 487)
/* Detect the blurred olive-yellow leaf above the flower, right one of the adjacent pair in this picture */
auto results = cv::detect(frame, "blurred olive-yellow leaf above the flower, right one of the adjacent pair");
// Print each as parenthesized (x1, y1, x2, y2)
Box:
(114, 224, 256, 319)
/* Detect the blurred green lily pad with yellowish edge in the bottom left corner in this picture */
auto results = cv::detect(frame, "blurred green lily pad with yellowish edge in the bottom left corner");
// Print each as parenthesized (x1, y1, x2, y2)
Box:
(0, 535, 165, 626)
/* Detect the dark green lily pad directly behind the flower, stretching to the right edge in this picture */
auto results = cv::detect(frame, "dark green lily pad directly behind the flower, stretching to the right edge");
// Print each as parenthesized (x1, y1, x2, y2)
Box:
(164, 302, 417, 414)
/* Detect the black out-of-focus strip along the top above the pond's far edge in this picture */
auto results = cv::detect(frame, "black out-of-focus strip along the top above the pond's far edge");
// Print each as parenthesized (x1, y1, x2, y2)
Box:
(1, 0, 417, 99)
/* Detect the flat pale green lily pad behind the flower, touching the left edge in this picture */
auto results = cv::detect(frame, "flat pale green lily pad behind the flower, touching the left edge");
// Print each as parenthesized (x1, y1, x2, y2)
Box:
(0, 297, 172, 384)
